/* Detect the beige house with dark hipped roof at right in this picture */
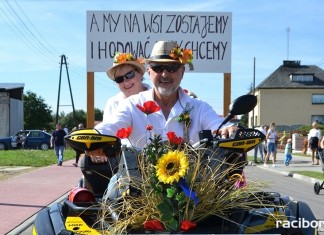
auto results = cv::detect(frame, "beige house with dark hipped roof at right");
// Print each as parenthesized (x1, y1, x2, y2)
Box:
(249, 60, 324, 127)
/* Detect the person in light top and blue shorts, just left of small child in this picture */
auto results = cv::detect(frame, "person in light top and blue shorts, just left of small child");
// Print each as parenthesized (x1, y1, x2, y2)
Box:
(263, 122, 277, 167)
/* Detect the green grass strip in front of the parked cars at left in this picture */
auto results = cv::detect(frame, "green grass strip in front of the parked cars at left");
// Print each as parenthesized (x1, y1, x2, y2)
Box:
(0, 149, 75, 167)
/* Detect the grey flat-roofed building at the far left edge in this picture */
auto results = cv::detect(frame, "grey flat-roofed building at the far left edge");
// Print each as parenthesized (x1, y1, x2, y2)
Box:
(0, 83, 25, 137)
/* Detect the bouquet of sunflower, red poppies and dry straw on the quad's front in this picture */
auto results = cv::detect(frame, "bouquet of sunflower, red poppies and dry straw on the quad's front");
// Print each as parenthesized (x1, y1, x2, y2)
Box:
(101, 100, 265, 234)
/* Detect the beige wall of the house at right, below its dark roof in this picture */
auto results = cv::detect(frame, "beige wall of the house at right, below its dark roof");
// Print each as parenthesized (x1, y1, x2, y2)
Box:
(249, 89, 324, 126)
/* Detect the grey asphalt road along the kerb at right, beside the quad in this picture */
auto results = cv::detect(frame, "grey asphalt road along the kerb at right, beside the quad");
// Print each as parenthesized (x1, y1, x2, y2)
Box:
(245, 163, 324, 220)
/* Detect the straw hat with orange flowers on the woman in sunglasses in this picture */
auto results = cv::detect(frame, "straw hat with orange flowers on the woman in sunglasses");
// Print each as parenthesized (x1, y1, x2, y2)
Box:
(106, 52, 145, 81)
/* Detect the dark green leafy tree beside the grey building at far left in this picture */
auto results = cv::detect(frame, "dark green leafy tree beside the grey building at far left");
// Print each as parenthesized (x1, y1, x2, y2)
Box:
(24, 91, 53, 130)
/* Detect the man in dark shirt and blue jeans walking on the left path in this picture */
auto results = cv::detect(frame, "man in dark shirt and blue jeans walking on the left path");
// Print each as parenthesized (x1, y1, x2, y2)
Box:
(51, 123, 66, 166)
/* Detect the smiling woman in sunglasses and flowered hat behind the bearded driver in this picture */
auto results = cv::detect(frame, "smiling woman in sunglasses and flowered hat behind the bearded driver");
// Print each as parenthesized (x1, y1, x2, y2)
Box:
(103, 52, 150, 121)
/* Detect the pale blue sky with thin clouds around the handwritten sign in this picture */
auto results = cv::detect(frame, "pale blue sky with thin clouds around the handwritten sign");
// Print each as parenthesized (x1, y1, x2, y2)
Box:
(0, 0, 324, 117)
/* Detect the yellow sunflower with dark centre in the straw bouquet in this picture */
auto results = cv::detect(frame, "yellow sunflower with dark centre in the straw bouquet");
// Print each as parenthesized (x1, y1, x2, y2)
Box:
(156, 150, 189, 184)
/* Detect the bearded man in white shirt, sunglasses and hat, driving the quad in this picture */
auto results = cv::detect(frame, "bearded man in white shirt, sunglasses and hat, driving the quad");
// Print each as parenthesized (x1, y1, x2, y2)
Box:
(89, 41, 227, 162)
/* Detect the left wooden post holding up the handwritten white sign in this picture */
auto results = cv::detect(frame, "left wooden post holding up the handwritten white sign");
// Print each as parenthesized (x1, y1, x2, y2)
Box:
(87, 72, 95, 128)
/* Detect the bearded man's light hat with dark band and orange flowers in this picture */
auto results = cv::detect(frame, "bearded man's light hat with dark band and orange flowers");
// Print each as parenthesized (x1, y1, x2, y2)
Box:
(145, 41, 193, 70)
